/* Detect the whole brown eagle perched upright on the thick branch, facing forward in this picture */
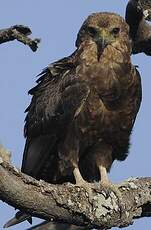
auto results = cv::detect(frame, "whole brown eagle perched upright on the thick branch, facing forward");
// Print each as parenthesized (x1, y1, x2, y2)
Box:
(5, 13, 141, 227)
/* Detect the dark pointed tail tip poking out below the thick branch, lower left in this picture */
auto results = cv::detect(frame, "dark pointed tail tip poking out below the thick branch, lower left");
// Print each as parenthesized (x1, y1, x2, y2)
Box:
(3, 211, 32, 228)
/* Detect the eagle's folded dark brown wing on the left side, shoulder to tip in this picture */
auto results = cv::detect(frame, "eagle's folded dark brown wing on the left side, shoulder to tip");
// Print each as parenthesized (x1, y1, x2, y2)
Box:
(22, 55, 90, 179)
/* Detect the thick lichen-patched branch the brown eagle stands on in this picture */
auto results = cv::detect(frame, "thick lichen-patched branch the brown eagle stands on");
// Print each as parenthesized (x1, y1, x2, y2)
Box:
(0, 160, 151, 229)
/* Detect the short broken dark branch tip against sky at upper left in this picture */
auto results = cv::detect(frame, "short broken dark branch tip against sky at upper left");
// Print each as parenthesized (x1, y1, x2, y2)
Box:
(0, 25, 40, 52)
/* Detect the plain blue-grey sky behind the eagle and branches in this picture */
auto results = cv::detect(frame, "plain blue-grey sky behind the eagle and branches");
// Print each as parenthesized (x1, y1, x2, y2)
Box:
(0, 0, 151, 230)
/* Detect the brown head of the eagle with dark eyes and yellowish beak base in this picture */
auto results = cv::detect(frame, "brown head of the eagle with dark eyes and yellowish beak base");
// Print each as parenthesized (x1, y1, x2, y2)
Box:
(76, 12, 130, 58)
